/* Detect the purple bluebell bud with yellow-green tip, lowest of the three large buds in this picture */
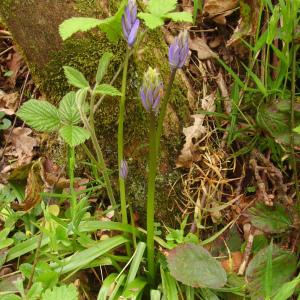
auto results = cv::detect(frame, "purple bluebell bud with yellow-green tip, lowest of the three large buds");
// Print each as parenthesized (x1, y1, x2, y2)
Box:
(140, 67, 163, 114)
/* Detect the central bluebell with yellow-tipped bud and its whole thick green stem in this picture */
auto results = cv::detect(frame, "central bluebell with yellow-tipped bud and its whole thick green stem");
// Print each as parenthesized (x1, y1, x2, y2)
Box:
(140, 68, 163, 286)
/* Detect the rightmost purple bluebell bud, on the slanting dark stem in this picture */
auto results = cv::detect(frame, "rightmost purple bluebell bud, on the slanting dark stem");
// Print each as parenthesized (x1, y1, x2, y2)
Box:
(169, 30, 189, 69)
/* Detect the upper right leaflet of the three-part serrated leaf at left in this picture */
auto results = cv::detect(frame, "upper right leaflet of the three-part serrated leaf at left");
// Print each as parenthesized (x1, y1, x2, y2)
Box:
(58, 92, 80, 125)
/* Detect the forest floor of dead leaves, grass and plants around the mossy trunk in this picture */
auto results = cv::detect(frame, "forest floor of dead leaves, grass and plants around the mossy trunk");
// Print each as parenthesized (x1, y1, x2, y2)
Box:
(0, 0, 300, 300)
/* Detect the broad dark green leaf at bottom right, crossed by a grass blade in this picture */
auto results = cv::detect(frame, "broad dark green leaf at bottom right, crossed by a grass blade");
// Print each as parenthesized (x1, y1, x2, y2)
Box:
(246, 245, 297, 300)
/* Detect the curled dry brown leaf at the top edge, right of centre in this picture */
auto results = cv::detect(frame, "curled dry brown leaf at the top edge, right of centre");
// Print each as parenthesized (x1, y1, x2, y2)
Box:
(203, 0, 239, 24)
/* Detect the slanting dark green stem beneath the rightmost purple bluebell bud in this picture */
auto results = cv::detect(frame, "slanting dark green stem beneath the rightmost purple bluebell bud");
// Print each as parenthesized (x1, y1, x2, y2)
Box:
(156, 69, 177, 153)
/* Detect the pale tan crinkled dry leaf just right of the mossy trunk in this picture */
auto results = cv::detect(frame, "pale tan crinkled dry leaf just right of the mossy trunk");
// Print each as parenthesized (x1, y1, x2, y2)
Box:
(176, 93, 215, 168)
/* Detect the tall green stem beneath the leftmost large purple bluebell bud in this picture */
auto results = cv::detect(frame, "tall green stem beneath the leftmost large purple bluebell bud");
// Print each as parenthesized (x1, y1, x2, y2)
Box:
(118, 49, 130, 224)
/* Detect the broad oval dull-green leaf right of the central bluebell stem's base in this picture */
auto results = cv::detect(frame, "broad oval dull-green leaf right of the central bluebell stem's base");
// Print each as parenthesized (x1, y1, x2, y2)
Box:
(167, 243, 227, 289)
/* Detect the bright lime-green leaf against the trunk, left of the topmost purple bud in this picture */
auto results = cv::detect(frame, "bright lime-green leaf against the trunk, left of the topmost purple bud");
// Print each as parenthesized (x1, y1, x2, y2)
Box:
(59, 17, 103, 40)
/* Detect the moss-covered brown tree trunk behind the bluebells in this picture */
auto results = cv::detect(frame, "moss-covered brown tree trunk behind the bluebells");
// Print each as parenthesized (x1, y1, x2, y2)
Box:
(0, 0, 189, 223)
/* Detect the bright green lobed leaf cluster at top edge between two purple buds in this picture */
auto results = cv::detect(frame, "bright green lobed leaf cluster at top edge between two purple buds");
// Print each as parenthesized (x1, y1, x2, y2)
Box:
(138, 0, 193, 29)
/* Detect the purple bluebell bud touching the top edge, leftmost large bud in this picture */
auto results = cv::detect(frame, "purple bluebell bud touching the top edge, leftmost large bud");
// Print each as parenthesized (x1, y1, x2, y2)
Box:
(122, 0, 140, 47)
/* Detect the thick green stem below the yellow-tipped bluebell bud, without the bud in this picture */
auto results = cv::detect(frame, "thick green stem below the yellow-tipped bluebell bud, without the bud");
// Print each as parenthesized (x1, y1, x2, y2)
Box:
(147, 113, 157, 286)
